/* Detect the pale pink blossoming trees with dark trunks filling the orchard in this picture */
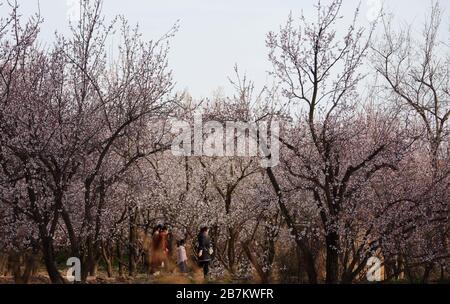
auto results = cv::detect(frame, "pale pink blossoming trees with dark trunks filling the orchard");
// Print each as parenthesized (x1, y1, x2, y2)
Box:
(0, 0, 450, 283)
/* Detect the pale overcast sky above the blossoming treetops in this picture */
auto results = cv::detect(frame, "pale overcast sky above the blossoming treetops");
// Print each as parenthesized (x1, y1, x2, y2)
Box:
(7, 0, 449, 98)
